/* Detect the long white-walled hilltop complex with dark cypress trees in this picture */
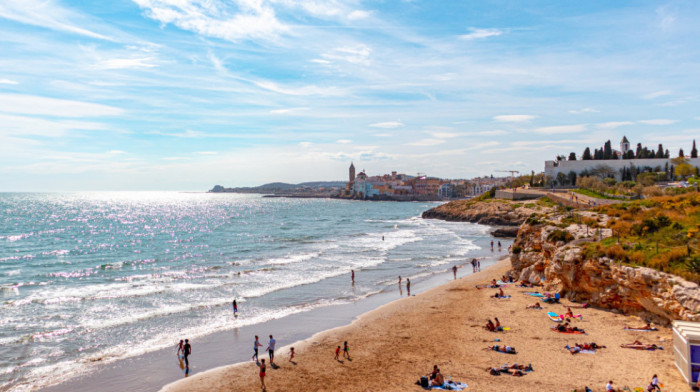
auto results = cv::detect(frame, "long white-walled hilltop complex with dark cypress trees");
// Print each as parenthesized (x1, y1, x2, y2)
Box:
(544, 136, 700, 185)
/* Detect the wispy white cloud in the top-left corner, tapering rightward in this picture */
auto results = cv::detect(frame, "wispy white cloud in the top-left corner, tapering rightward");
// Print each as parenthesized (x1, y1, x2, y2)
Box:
(0, 0, 114, 41)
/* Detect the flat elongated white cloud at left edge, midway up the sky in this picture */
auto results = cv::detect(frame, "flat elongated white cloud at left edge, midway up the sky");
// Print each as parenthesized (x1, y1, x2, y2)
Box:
(0, 94, 124, 117)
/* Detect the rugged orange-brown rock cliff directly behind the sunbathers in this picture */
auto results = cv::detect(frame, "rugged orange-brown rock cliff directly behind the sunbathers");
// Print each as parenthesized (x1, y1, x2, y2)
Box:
(511, 212, 700, 324)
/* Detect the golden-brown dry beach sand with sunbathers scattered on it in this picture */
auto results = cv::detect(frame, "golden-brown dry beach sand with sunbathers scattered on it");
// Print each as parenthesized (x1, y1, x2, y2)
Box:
(163, 259, 689, 392)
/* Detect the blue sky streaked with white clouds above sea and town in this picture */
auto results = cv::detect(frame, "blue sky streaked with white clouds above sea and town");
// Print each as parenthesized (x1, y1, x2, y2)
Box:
(0, 0, 700, 191)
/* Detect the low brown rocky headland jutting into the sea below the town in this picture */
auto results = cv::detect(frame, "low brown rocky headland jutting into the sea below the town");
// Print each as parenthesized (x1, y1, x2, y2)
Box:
(421, 200, 549, 226)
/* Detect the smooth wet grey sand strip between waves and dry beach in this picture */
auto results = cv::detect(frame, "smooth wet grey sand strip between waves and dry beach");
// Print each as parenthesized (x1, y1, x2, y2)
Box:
(40, 254, 502, 392)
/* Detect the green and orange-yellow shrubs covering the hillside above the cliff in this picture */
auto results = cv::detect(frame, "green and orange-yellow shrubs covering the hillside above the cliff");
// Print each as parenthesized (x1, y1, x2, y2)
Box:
(586, 191, 700, 282)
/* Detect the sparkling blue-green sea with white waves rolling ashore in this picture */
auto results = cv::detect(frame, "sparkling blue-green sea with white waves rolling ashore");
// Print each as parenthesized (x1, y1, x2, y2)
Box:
(0, 192, 504, 391)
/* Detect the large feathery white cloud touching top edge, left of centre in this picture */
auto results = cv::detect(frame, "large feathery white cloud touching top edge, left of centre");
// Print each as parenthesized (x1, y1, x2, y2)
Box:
(134, 0, 289, 42)
